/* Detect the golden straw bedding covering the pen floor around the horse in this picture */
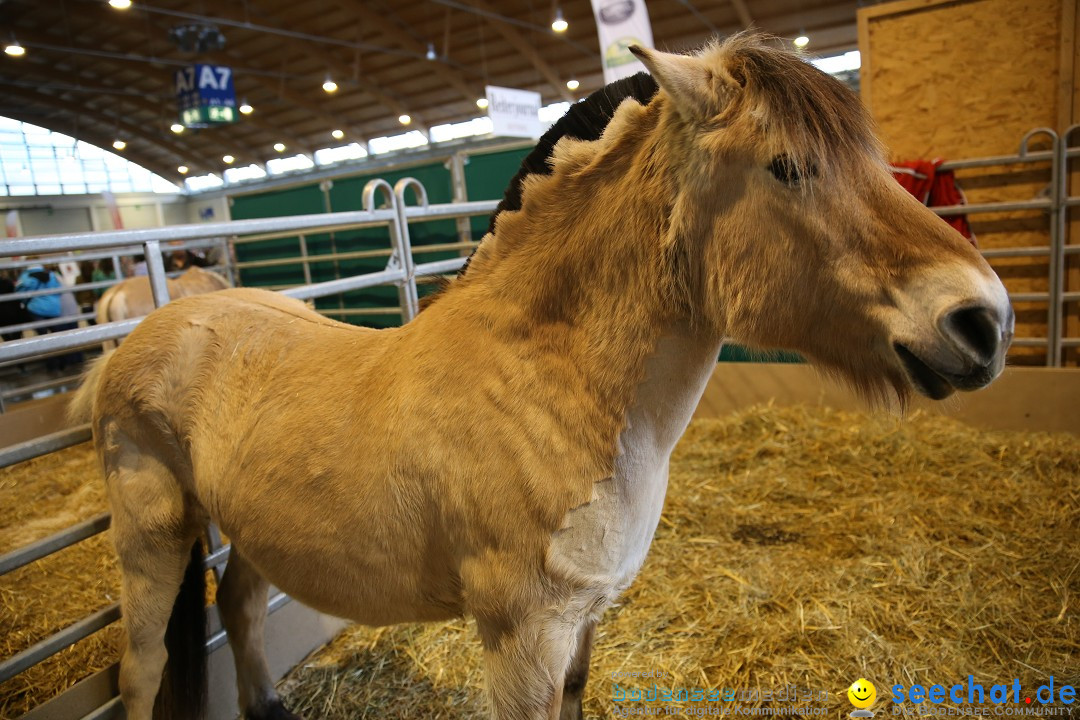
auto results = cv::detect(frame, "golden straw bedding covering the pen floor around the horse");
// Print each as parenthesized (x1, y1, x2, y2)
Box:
(0, 407, 1080, 719)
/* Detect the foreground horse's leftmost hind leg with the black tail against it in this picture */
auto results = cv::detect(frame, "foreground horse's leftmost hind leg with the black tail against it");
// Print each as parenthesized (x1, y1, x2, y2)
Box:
(109, 442, 206, 720)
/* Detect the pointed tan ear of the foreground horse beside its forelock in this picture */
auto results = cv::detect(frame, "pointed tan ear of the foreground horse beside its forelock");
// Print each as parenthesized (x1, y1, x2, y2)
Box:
(629, 45, 742, 118)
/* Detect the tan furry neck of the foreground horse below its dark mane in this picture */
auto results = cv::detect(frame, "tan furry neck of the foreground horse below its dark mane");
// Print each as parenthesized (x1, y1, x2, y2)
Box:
(420, 97, 719, 472)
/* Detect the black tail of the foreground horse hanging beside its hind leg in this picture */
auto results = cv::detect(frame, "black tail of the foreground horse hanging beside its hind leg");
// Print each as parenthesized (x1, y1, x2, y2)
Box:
(153, 540, 208, 720)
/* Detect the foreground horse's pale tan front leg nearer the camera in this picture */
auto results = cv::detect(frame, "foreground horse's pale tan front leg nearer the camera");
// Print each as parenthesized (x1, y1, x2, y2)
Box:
(476, 610, 582, 720)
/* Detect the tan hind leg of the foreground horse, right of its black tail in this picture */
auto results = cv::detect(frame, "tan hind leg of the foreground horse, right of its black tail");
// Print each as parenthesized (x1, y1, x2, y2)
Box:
(217, 546, 300, 720)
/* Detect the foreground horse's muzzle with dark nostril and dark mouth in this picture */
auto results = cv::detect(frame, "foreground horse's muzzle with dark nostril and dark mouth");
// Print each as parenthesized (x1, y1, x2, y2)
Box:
(893, 303, 1015, 400)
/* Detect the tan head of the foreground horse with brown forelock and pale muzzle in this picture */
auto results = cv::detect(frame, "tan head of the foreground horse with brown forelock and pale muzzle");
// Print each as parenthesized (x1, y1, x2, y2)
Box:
(634, 35, 1014, 403)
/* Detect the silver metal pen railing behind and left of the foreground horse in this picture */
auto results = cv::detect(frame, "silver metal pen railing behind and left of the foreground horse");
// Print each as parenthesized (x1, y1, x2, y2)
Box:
(0, 178, 498, 717)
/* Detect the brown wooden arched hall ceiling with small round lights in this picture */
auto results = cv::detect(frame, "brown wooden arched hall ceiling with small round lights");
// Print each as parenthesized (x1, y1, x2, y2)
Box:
(0, 0, 860, 181)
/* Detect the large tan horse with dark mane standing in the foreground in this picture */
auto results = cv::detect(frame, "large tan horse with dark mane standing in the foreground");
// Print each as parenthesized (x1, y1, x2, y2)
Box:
(71, 35, 1014, 720)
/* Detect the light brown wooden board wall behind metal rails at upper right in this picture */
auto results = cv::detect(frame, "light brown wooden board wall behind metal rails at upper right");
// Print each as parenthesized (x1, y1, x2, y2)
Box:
(859, 0, 1076, 365)
